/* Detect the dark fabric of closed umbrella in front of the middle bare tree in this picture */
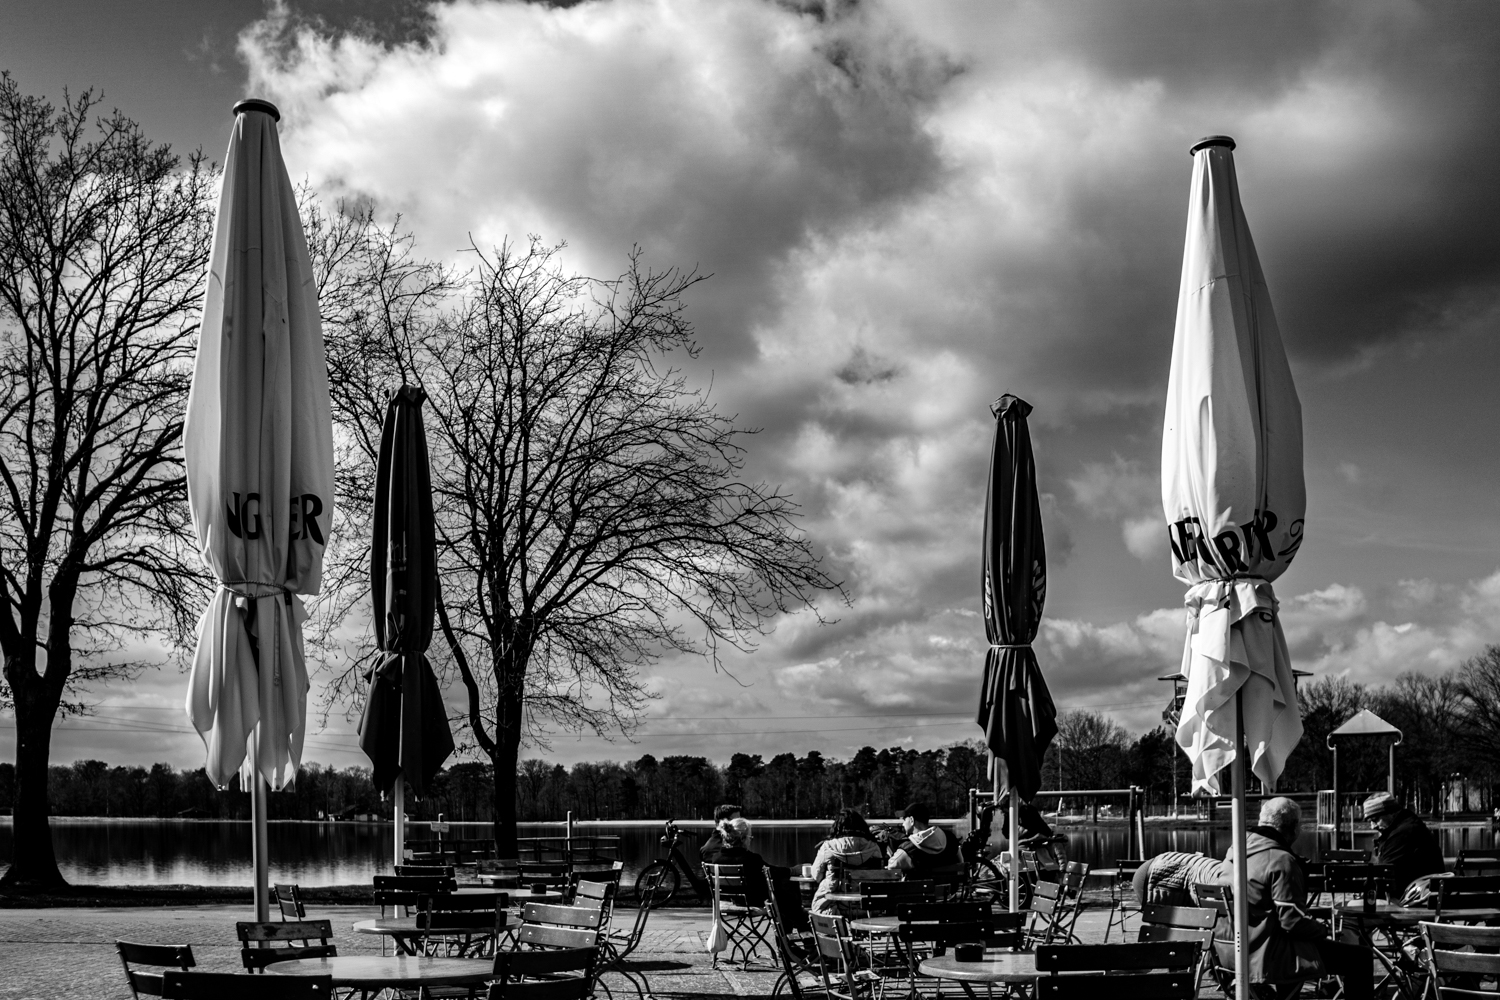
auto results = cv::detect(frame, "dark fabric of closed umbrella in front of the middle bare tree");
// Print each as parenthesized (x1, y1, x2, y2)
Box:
(360, 385, 453, 798)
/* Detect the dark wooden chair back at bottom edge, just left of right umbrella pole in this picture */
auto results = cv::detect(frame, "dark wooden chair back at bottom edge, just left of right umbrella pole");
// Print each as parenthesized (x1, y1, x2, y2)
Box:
(1037, 942, 1202, 1000)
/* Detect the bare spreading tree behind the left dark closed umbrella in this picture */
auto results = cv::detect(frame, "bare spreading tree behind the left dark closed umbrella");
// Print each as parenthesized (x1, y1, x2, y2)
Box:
(312, 230, 843, 856)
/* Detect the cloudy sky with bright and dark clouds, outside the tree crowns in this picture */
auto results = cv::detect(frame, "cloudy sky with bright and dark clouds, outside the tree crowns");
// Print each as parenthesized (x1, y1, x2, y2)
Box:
(0, 0, 1500, 766)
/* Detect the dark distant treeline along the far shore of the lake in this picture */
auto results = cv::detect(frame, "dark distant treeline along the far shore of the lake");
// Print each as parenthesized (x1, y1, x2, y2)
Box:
(11, 646, 1500, 822)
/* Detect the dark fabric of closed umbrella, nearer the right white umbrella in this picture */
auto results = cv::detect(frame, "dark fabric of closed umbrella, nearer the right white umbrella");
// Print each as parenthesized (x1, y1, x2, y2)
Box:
(978, 396, 1058, 799)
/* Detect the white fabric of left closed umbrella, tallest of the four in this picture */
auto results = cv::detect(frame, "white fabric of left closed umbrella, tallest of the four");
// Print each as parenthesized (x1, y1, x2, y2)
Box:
(183, 102, 333, 789)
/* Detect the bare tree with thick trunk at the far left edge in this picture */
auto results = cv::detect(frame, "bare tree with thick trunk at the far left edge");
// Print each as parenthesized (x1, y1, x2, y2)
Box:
(0, 80, 215, 885)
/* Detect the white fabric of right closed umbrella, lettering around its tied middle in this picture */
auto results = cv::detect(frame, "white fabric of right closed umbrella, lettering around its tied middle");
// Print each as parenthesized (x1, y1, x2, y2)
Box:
(1161, 139, 1307, 793)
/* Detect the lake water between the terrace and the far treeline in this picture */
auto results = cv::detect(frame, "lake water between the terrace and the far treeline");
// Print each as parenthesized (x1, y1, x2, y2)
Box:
(0, 819, 1496, 886)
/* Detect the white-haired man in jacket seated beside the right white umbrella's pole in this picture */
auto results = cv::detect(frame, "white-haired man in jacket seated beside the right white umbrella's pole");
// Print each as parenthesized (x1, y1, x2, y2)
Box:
(1215, 796, 1374, 1000)
